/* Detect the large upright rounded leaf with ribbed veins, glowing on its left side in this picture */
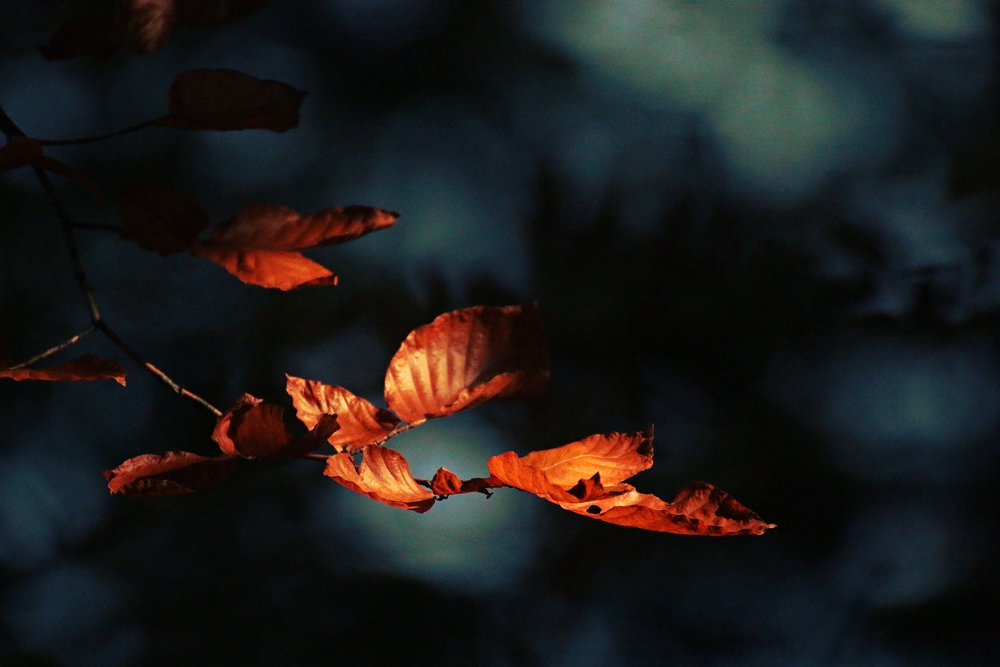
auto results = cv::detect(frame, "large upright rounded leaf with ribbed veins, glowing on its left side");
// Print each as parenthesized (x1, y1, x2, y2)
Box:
(385, 304, 549, 422)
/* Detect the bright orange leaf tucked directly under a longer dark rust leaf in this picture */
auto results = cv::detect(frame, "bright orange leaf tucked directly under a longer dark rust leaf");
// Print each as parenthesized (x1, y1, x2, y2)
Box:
(191, 241, 337, 291)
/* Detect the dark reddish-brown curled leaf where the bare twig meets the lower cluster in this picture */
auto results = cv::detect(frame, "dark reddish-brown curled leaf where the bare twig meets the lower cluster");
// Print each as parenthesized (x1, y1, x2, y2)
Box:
(212, 394, 339, 459)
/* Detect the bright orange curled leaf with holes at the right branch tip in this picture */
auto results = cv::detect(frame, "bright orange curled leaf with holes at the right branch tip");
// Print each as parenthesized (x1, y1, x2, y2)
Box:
(487, 433, 774, 535)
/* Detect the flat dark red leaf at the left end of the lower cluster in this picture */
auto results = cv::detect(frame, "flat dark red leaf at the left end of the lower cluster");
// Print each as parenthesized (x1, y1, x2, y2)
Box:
(104, 452, 236, 496)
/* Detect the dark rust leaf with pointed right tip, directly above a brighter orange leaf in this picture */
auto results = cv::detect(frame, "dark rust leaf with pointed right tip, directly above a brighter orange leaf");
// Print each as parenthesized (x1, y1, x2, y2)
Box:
(212, 204, 399, 250)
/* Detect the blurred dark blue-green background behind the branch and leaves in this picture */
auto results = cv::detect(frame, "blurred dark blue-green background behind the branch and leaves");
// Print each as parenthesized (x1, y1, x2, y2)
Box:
(0, 0, 1000, 667)
